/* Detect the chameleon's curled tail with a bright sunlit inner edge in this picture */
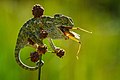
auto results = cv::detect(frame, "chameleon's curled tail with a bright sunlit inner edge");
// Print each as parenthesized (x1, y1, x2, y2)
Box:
(15, 45, 38, 71)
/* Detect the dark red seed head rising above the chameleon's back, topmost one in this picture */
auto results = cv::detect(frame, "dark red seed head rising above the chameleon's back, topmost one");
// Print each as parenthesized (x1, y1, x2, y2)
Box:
(32, 4, 44, 18)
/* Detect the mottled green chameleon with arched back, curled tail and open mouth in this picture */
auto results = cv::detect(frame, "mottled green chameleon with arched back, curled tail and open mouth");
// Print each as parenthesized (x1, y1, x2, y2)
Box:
(15, 14, 79, 70)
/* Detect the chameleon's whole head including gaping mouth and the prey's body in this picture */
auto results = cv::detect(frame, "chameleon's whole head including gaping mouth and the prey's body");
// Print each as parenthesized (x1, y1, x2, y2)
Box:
(53, 14, 80, 43)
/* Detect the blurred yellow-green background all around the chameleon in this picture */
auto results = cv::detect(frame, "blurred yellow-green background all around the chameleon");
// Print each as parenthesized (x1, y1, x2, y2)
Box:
(0, 0, 120, 80)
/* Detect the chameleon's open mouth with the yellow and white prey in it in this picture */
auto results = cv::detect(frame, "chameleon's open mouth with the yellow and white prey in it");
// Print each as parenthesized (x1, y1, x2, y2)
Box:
(59, 26, 80, 43)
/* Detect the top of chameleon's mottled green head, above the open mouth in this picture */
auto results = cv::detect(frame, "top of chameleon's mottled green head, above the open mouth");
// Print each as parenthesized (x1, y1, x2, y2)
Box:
(54, 14, 74, 28)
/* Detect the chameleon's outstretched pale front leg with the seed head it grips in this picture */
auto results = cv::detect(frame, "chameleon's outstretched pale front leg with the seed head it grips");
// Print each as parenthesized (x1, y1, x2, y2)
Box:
(48, 38, 65, 58)
